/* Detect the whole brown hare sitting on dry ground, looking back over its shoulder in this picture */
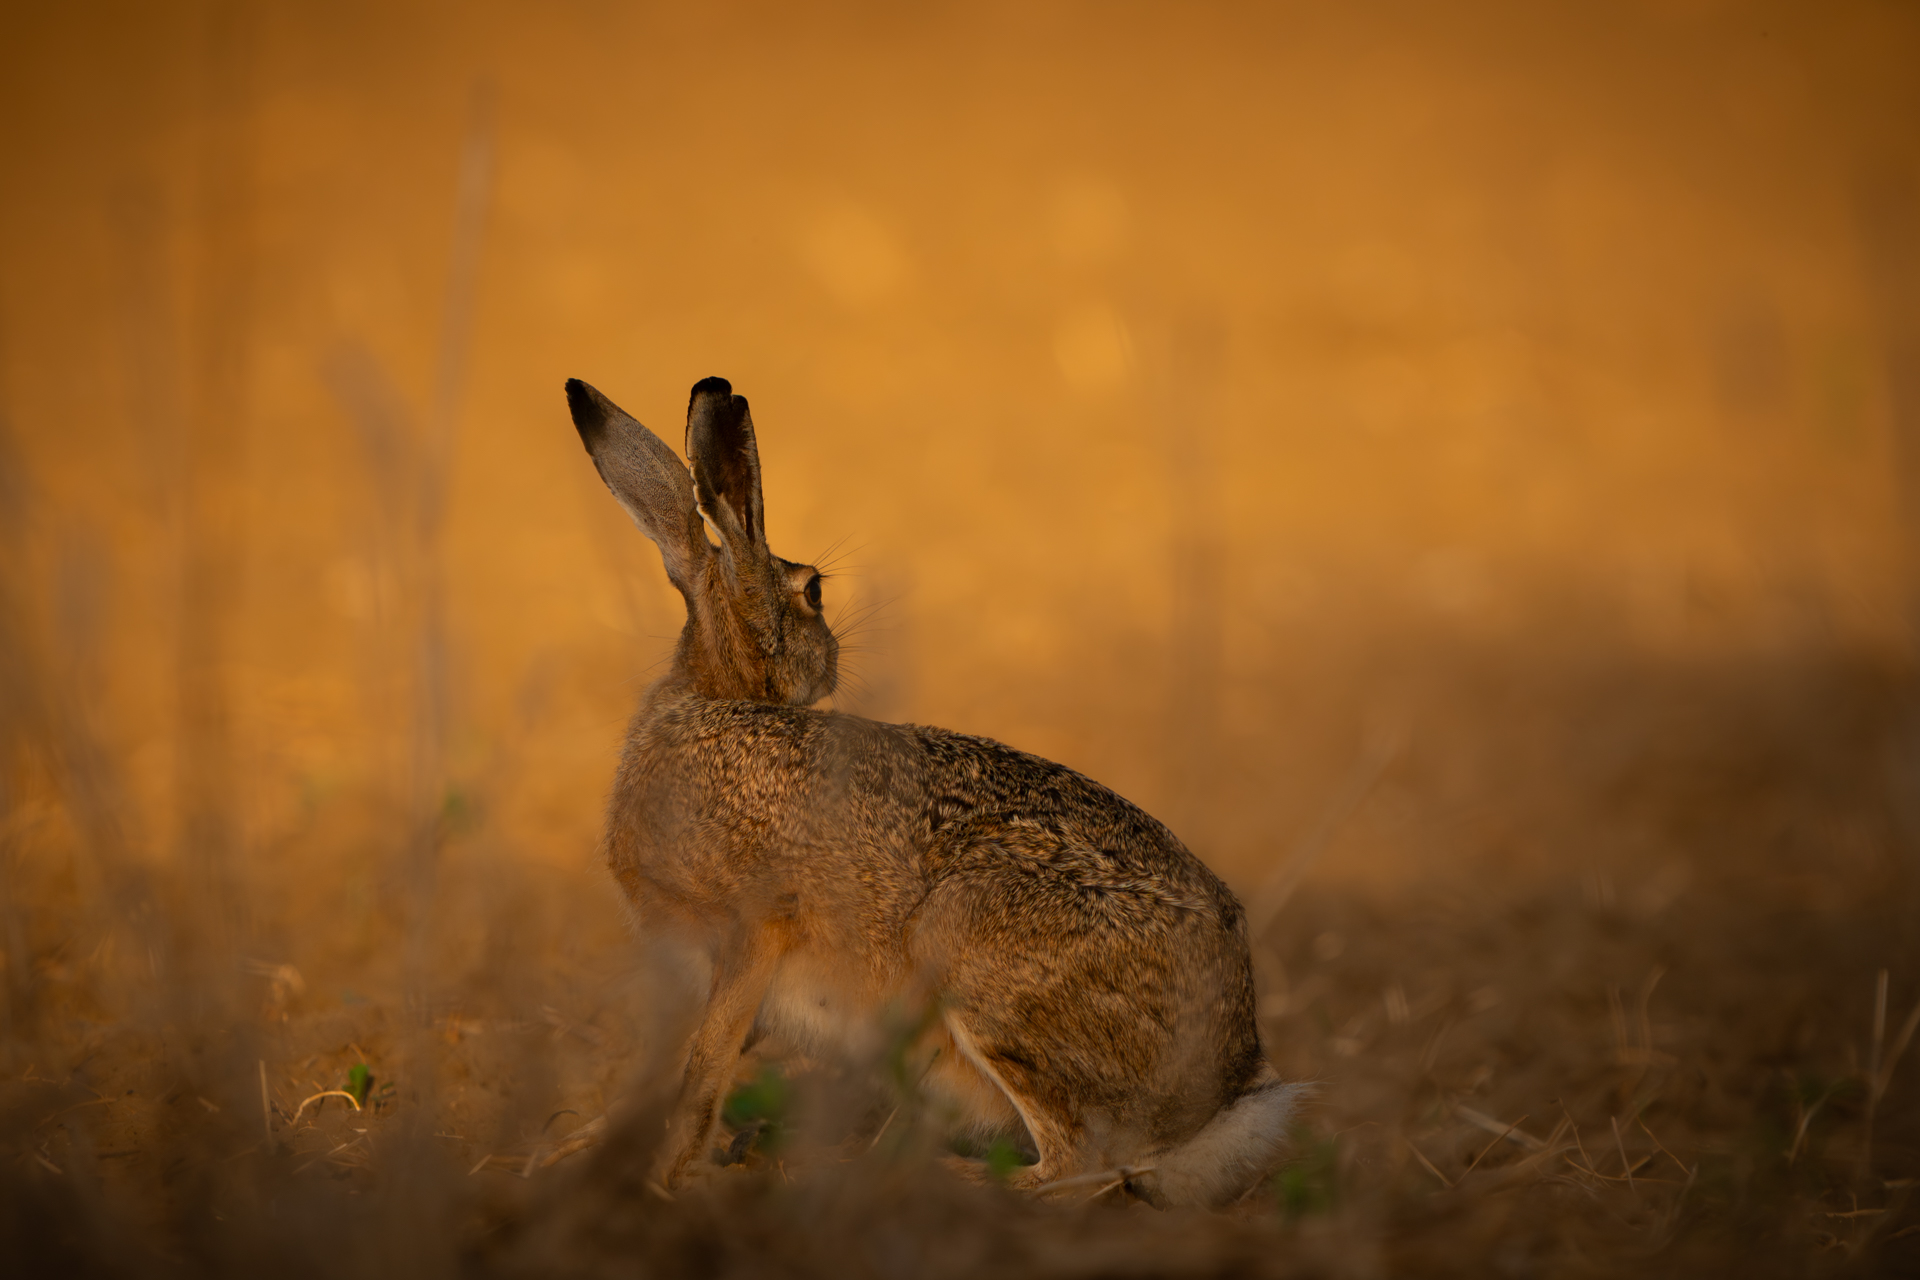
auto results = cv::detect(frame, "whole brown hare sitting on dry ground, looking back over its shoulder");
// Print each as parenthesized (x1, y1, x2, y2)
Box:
(566, 378, 1300, 1205)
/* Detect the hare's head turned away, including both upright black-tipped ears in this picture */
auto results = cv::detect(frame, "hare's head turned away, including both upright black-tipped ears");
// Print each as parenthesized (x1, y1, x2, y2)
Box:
(566, 378, 839, 706)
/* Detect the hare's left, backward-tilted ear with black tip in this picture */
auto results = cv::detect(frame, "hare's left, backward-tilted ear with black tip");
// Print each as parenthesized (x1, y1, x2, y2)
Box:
(566, 378, 708, 595)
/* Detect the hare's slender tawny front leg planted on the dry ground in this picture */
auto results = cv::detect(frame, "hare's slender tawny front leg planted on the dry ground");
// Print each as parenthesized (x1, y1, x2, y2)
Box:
(655, 929, 780, 1186)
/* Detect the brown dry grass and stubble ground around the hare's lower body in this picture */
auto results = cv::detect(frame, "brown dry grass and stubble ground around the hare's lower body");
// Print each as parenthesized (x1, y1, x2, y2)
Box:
(0, 652, 1920, 1276)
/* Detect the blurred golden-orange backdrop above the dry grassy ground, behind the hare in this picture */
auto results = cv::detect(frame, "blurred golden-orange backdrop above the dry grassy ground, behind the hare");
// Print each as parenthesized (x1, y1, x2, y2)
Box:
(0, 0, 1920, 909)
